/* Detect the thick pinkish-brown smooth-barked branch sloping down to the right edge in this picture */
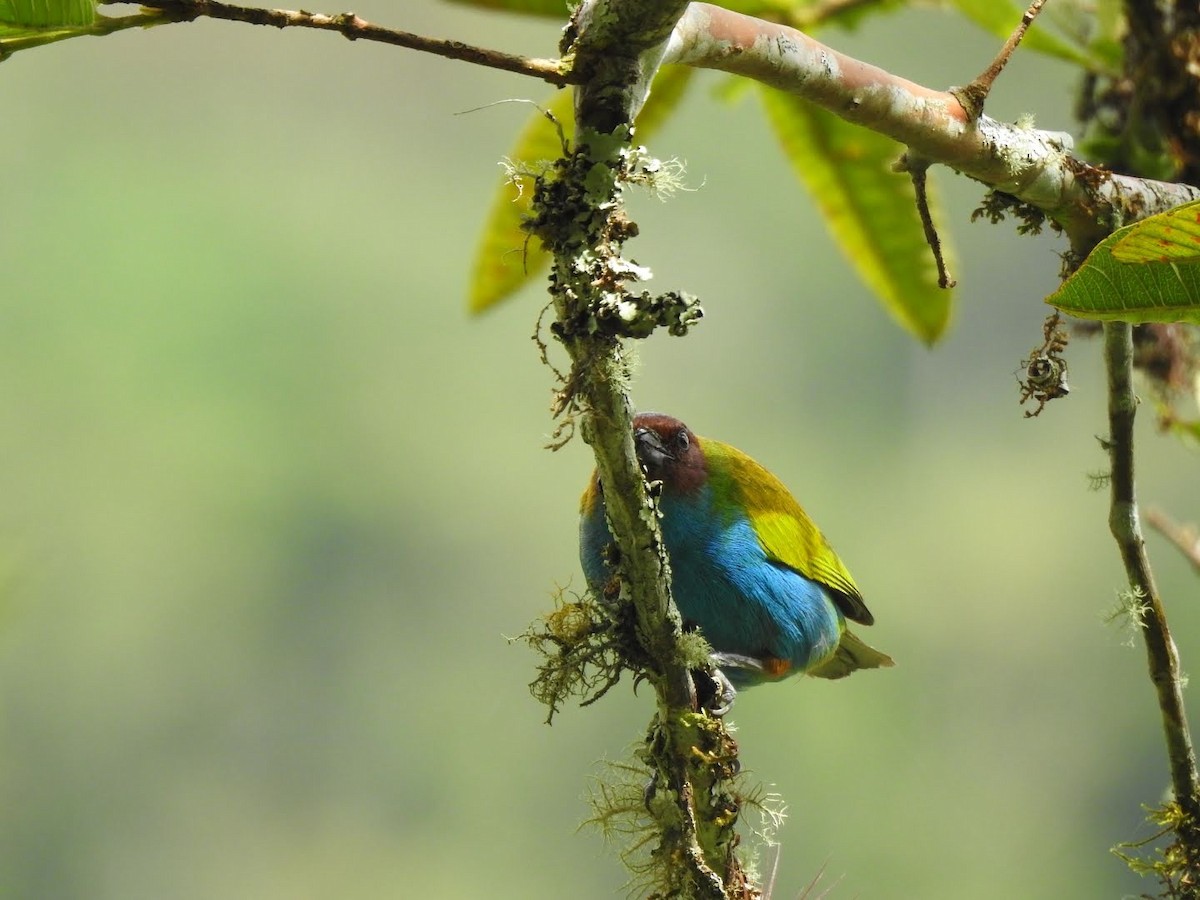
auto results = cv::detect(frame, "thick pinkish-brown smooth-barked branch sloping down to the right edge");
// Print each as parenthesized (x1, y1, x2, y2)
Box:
(664, 2, 1200, 244)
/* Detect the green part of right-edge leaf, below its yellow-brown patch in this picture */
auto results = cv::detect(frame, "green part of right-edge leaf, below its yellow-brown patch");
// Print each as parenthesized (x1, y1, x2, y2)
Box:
(1046, 224, 1200, 324)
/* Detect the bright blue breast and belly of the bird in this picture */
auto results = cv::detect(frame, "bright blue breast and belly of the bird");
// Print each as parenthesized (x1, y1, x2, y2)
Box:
(580, 485, 842, 686)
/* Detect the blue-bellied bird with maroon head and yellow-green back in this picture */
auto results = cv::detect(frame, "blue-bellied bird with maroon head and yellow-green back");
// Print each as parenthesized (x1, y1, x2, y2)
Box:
(580, 413, 895, 702)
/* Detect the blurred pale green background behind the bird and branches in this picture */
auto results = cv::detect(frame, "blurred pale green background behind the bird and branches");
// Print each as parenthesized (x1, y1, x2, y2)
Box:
(0, 0, 1200, 900)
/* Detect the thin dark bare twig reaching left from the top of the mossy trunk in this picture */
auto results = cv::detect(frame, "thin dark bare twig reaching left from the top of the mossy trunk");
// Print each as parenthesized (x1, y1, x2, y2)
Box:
(104, 0, 569, 85)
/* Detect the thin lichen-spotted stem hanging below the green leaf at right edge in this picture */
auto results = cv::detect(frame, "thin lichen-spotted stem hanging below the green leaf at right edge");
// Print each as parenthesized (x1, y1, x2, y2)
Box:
(1104, 322, 1200, 825)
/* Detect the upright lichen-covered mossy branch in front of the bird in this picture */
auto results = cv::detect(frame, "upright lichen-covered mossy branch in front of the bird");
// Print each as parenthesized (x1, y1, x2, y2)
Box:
(528, 0, 755, 900)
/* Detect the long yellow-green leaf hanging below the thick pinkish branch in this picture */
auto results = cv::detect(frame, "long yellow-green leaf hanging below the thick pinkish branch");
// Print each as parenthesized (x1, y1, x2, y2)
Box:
(761, 88, 953, 343)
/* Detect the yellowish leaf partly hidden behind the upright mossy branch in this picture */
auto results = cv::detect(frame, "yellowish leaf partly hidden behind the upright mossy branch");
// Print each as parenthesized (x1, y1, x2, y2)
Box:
(468, 66, 694, 313)
